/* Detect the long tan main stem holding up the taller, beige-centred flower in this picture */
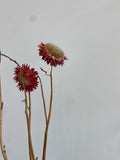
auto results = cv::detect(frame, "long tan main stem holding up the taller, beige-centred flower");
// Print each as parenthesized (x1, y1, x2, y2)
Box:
(42, 67, 53, 160)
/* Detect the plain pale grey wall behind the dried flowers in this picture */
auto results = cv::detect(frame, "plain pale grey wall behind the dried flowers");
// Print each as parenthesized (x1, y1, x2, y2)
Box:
(0, 0, 120, 160)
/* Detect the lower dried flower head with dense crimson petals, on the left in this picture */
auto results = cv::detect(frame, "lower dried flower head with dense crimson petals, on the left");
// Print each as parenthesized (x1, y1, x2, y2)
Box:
(14, 64, 38, 92)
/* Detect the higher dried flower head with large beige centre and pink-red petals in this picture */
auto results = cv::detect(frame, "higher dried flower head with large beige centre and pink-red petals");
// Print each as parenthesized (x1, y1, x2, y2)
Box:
(38, 43, 67, 67)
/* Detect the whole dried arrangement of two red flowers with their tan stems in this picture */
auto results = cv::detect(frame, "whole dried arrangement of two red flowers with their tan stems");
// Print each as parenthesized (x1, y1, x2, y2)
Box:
(0, 43, 67, 160)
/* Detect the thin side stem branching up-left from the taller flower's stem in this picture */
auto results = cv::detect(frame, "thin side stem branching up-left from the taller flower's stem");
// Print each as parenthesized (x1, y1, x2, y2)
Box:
(38, 76, 47, 125)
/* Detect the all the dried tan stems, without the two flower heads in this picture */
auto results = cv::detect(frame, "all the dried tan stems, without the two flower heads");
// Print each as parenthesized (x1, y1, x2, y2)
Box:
(0, 51, 53, 160)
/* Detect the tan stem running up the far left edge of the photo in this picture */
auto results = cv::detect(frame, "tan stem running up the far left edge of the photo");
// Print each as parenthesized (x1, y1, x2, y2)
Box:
(0, 78, 8, 160)
